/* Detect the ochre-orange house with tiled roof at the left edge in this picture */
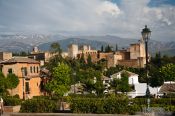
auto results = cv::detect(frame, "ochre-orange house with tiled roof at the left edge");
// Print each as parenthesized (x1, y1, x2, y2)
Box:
(1, 57, 41, 99)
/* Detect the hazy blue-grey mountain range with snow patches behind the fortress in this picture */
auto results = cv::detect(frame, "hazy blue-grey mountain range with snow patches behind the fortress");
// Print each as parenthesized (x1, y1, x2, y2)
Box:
(0, 34, 175, 56)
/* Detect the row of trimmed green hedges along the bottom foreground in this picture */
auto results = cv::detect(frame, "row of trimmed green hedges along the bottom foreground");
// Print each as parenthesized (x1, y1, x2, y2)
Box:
(20, 95, 175, 114)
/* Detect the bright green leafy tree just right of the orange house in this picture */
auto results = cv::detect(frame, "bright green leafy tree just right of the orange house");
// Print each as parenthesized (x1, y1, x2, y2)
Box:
(46, 63, 71, 96)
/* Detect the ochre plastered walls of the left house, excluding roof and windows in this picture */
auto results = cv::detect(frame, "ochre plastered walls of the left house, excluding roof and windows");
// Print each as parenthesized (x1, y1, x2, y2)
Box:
(2, 63, 41, 99)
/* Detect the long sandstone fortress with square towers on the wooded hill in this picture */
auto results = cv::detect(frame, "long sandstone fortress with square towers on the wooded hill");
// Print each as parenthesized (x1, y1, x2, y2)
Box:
(68, 37, 146, 68)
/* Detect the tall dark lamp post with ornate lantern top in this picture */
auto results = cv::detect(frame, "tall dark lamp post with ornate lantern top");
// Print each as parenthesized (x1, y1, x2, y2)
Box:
(141, 25, 151, 111)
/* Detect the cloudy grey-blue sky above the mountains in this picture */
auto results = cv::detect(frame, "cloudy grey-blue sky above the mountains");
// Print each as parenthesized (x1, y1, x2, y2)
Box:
(0, 0, 175, 41)
